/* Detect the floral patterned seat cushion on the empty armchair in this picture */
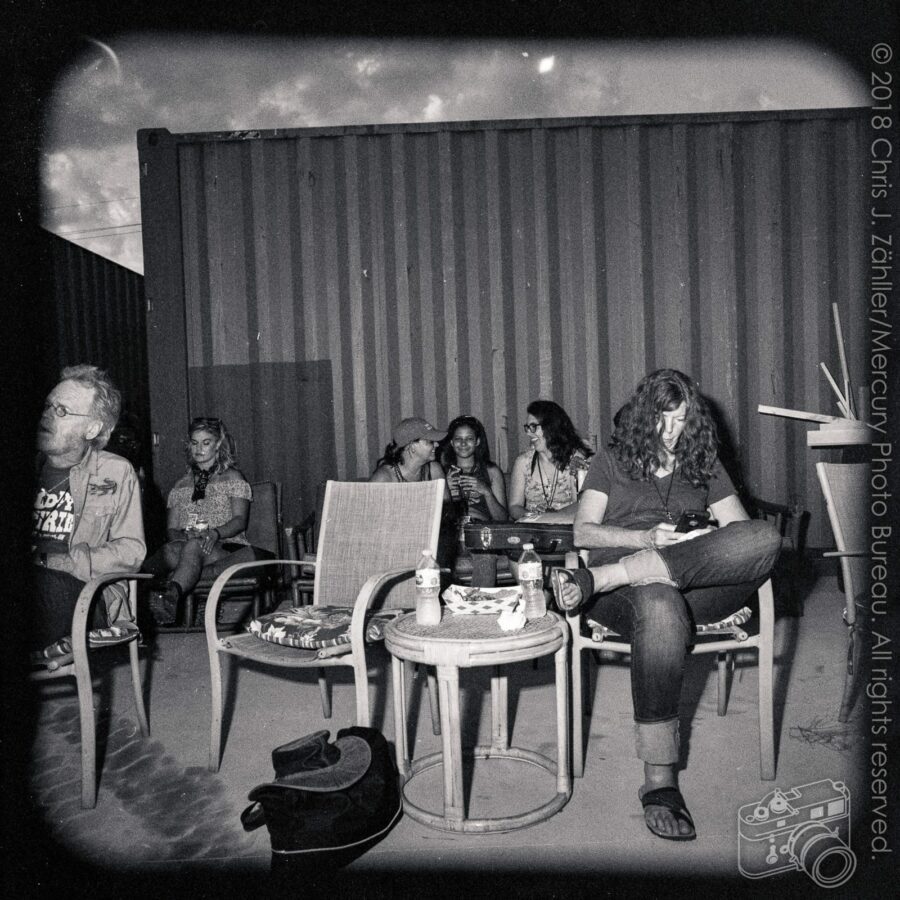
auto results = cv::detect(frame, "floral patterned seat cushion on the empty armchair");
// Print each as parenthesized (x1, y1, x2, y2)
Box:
(247, 606, 409, 650)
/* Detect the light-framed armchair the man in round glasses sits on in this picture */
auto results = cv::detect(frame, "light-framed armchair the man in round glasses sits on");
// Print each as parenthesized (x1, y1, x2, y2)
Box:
(29, 572, 153, 809)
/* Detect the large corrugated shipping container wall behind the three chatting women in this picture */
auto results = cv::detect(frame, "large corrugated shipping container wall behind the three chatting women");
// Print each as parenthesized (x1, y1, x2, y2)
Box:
(139, 110, 865, 544)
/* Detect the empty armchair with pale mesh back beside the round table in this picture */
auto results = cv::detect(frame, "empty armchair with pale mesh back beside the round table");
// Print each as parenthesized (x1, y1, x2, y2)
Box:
(205, 480, 444, 772)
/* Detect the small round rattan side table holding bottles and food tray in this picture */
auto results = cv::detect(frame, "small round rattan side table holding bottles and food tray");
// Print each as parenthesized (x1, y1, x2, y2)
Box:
(384, 610, 572, 834)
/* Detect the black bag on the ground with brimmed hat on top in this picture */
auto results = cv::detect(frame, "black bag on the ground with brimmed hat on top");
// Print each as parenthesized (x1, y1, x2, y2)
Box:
(241, 726, 403, 877)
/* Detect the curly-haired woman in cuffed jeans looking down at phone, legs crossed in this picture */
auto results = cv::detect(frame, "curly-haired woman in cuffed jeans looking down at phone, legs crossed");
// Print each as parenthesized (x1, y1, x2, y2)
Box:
(550, 369, 781, 841)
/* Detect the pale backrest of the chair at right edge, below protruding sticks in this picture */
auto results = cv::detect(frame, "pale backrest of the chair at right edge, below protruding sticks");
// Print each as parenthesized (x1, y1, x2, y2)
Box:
(816, 463, 870, 604)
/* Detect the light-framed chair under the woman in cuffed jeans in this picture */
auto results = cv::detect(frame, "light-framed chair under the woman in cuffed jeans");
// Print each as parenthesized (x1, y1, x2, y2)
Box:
(566, 551, 775, 781)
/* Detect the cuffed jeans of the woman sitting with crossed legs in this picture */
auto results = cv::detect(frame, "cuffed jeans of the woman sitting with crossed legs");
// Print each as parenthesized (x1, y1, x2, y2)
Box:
(585, 520, 781, 765)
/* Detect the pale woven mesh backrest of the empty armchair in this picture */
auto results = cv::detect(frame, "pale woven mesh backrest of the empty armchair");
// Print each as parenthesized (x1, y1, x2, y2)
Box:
(314, 480, 444, 607)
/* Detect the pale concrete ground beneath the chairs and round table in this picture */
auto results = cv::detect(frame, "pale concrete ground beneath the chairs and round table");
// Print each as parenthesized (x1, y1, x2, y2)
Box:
(14, 577, 884, 897)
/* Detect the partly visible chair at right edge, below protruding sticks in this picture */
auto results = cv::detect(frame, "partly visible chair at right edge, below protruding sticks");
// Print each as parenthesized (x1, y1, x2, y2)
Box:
(816, 463, 870, 722)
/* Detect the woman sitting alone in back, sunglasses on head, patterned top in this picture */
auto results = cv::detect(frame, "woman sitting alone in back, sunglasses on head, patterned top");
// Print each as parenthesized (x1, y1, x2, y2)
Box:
(144, 416, 254, 625)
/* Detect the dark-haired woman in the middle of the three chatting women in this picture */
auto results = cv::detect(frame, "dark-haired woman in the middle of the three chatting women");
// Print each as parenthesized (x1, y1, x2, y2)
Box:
(441, 416, 507, 522)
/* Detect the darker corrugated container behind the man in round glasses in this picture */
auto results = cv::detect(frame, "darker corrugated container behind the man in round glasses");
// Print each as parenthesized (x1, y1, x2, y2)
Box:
(40, 232, 150, 459)
